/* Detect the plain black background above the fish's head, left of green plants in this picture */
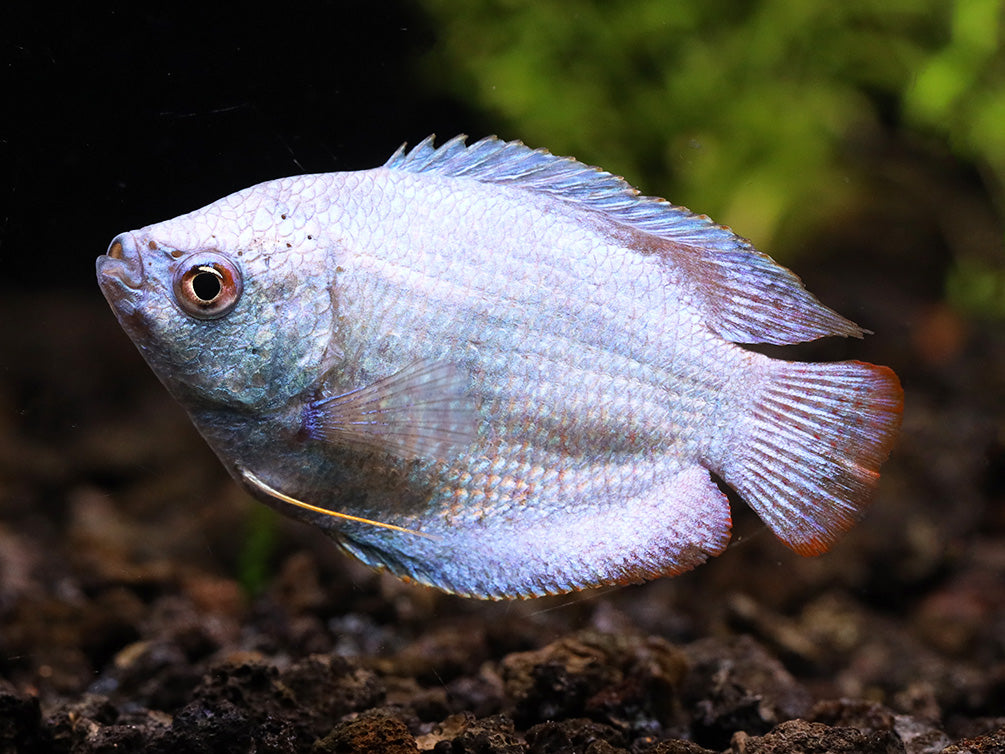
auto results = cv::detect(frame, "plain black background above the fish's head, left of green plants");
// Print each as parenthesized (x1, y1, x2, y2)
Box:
(0, 2, 482, 290)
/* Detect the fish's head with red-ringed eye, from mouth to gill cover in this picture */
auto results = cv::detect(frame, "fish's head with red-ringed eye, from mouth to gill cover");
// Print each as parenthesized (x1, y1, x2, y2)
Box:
(96, 210, 334, 413)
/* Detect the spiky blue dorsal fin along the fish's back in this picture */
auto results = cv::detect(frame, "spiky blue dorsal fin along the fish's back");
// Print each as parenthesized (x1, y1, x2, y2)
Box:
(384, 135, 865, 345)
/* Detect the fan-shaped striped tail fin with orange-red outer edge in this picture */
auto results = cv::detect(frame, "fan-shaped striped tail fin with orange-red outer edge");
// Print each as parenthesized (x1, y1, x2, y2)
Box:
(723, 361, 903, 555)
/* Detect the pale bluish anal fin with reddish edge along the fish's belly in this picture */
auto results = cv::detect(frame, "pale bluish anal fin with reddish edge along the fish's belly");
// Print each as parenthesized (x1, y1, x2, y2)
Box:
(343, 462, 732, 599)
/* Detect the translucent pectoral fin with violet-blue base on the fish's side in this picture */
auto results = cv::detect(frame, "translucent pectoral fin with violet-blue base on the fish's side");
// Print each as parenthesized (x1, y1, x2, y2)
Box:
(304, 359, 478, 461)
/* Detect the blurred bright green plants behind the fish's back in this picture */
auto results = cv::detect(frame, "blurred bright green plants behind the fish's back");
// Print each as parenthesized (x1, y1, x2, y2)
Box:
(422, 0, 1005, 317)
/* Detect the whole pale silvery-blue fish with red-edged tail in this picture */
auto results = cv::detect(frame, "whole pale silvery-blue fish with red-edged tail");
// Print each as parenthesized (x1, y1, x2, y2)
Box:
(96, 136, 903, 599)
